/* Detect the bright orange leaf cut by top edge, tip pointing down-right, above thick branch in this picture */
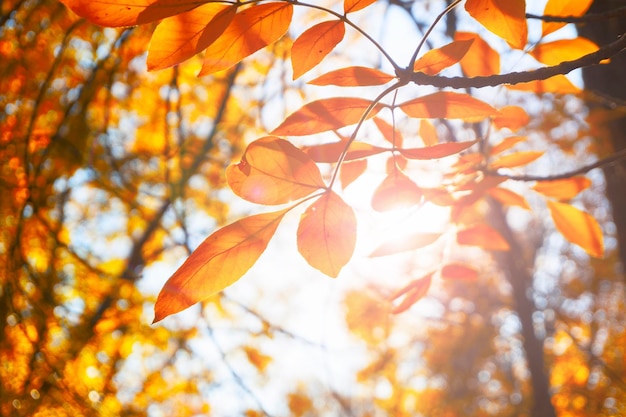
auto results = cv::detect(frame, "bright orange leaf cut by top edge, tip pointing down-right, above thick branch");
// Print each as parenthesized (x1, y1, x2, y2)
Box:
(465, 0, 528, 49)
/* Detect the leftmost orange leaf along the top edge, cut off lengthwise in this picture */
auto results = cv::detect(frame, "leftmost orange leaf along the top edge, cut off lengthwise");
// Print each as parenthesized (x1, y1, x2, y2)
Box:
(61, 0, 201, 27)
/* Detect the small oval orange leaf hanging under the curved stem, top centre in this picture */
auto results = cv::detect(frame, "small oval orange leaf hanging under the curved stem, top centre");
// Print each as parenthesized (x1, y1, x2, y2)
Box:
(291, 20, 346, 80)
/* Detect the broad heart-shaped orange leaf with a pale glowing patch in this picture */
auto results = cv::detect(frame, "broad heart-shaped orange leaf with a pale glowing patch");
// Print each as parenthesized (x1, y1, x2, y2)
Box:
(226, 136, 326, 205)
